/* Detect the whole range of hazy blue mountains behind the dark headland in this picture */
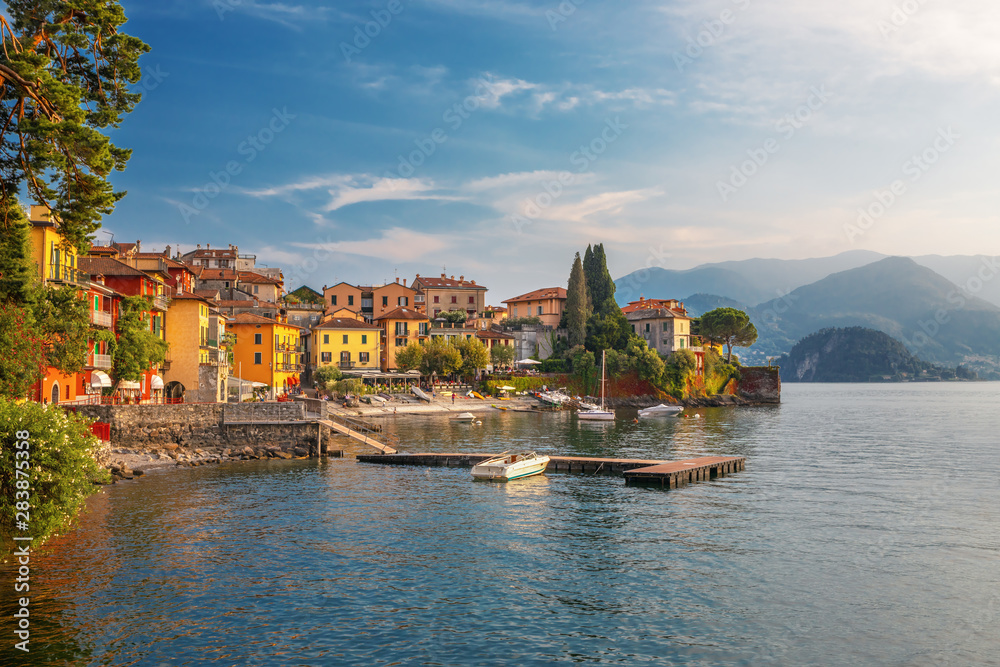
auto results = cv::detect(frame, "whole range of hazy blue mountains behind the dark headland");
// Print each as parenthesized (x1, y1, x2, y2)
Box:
(616, 251, 1000, 379)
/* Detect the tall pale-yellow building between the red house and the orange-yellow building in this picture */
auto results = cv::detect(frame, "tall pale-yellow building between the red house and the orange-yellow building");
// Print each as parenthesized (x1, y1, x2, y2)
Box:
(163, 294, 228, 403)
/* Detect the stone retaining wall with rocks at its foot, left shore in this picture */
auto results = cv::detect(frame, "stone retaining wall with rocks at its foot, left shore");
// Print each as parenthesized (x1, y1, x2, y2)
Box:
(70, 403, 329, 479)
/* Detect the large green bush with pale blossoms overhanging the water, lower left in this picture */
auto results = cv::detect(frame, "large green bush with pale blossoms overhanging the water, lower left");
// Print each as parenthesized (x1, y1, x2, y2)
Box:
(0, 398, 108, 548)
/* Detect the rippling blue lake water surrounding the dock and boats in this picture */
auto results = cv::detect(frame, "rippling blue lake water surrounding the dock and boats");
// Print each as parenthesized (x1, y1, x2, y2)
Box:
(0, 383, 1000, 665)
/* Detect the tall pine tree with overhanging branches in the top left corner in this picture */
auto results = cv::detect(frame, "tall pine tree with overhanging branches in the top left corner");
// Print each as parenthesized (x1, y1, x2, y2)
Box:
(0, 0, 149, 253)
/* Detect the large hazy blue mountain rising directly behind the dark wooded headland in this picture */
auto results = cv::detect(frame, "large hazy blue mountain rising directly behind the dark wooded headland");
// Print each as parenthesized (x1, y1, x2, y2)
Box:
(748, 257, 1000, 375)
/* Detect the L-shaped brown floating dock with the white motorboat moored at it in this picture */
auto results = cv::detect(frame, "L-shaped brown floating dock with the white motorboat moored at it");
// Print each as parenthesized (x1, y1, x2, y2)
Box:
(358, 453, 746, 489)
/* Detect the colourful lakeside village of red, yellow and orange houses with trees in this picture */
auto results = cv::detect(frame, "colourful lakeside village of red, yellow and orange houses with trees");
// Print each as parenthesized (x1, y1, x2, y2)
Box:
(17, 206, 777, 406)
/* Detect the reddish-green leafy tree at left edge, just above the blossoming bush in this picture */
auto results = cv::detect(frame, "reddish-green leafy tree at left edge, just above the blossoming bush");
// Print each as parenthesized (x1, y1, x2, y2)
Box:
(0, 301, 45, 399)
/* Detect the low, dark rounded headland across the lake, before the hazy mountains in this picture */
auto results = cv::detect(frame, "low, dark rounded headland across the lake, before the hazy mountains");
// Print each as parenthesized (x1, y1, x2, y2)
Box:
(777, 327, 955, 382)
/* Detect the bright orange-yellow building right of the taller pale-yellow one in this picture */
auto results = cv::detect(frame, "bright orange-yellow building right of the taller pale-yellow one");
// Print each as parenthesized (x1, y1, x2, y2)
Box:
(226, 313, 303, 396)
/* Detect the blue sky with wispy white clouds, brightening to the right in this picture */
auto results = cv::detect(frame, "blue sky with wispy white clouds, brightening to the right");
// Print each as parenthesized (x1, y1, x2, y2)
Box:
(90, 0, 1000, 304)
